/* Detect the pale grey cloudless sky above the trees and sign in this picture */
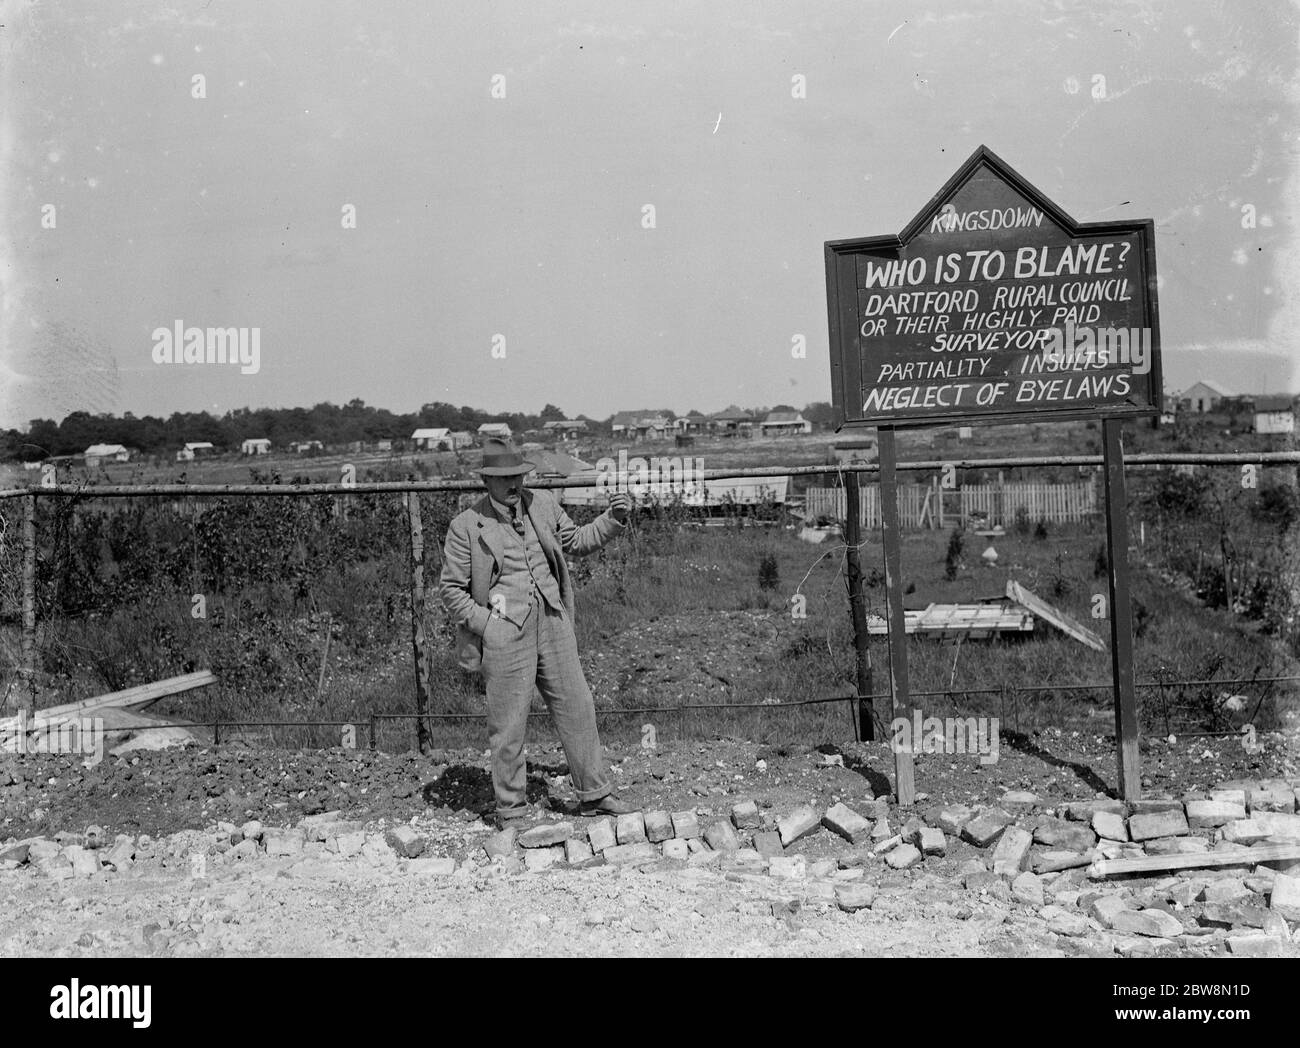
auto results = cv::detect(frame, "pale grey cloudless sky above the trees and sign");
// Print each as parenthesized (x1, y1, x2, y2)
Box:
(0, 0, 1300, 428)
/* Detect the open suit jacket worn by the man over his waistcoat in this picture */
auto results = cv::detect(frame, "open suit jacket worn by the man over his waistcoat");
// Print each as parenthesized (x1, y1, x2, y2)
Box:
(438, 488, 627, 672)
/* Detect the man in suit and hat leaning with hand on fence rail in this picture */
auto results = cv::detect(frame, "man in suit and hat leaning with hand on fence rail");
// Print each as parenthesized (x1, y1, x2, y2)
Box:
(438, 439, 636, 824)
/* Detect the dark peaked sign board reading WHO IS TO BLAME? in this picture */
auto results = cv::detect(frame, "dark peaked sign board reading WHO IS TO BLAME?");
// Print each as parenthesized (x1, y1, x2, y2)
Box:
(826, 146, 1162, 426)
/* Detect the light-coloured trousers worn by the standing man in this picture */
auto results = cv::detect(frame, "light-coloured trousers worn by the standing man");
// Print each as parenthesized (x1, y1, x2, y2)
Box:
(482, 602, 610, 818)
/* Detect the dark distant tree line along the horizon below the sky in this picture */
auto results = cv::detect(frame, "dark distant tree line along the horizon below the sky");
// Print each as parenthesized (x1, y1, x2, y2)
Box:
(0, 399, 831, 462)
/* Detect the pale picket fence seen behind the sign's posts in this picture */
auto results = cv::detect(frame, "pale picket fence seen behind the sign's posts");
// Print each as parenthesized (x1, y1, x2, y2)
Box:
(805, 481, 1101, 528)
